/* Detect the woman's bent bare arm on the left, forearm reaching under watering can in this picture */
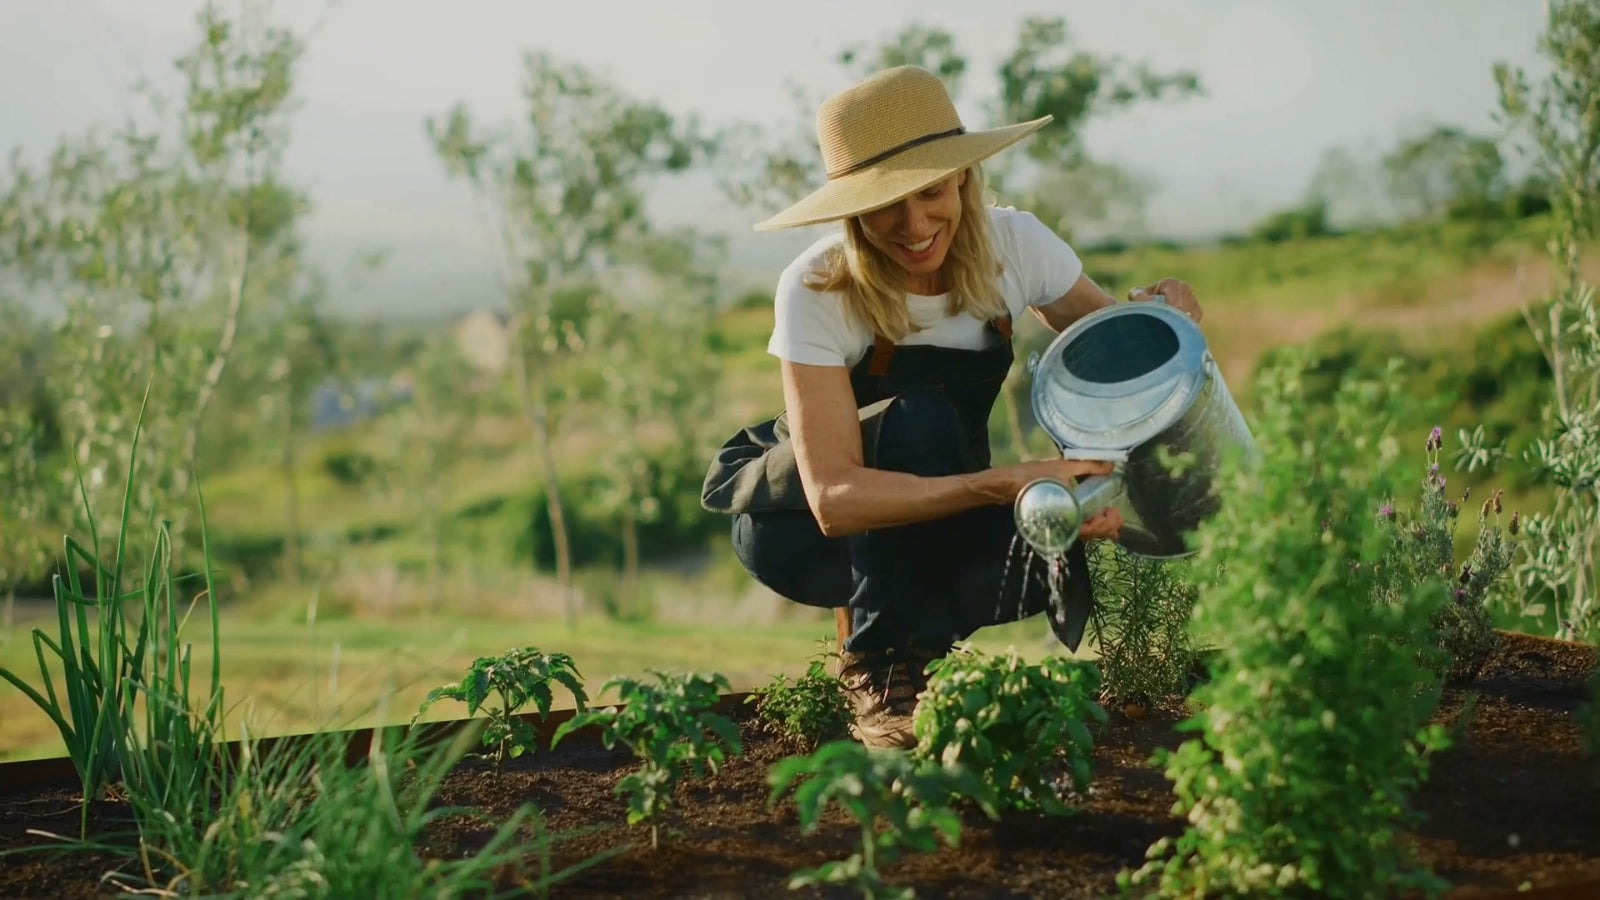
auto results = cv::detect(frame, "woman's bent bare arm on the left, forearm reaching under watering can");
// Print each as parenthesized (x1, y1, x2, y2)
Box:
(782, 360, 1110, 536)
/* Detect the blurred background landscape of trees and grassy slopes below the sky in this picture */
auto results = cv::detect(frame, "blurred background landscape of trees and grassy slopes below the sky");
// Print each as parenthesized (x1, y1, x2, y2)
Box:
(0, 3, 1600, 757)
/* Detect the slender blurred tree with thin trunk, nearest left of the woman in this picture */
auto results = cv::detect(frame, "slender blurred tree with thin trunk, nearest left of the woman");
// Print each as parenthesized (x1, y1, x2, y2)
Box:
(426, 51, 707, 623)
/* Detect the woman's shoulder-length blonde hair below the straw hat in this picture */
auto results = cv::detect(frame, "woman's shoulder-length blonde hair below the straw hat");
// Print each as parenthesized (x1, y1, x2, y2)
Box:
(805, 165, 1006, 341)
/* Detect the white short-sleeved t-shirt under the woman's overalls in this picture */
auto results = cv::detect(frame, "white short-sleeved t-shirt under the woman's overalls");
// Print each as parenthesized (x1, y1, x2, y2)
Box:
(766, 207, 1083, 367)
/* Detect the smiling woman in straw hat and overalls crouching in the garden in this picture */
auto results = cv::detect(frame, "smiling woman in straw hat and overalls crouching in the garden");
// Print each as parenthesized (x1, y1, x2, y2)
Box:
(702, 66, 1200, 746)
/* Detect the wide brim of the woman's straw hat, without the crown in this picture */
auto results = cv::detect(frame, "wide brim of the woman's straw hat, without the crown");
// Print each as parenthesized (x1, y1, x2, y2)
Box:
(755, 115, 1051, 231)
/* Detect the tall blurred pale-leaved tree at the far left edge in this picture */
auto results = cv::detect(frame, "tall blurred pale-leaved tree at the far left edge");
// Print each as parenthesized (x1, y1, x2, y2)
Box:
(0, 0, 304, 560)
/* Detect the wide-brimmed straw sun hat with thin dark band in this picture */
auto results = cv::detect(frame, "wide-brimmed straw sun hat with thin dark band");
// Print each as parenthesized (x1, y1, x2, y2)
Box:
(755, 66, 1051, 231)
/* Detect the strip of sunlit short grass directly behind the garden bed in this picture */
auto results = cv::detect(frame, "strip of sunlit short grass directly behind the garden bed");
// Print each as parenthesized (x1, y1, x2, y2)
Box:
(0, 592, 1048, 759)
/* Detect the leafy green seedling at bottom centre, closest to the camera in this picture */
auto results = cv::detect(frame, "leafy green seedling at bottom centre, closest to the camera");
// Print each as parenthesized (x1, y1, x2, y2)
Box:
(768, 740, 998, 900)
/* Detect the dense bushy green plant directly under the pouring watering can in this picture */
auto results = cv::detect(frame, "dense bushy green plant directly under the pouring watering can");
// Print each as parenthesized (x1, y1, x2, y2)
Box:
(912, 645, 1106, 815)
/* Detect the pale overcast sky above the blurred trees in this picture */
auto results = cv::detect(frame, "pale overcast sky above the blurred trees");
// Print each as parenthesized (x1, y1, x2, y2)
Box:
(0, 0, 1542, 317)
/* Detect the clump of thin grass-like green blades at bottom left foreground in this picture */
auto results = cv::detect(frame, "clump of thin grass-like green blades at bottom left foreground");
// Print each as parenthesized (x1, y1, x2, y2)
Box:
(112, 722, 616, 900)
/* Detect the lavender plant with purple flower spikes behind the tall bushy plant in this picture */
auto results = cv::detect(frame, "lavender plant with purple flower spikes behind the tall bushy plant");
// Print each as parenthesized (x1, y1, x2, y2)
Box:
(1376, 426, 1515, 682)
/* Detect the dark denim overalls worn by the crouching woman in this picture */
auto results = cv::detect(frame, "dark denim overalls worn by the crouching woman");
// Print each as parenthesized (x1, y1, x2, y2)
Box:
(701, 317, 1093, 652)
